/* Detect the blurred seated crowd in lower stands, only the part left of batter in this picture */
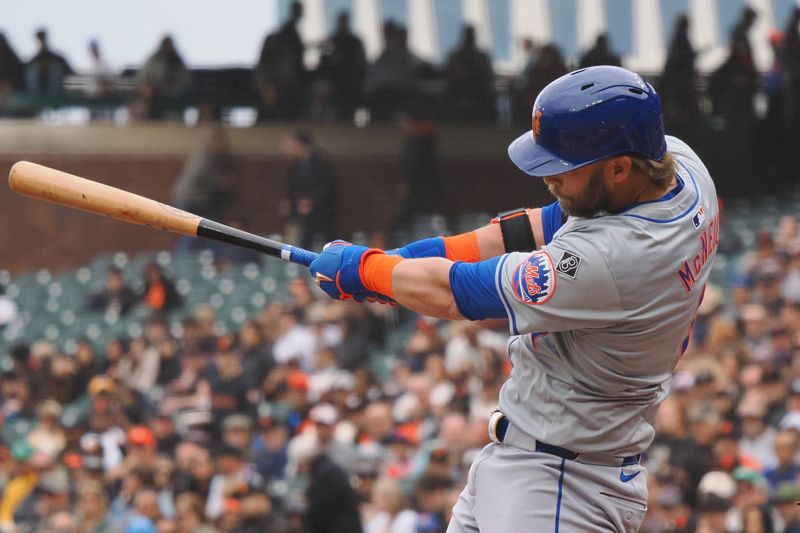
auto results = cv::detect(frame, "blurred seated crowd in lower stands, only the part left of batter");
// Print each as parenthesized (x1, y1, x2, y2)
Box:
(0, 247, 508, 533)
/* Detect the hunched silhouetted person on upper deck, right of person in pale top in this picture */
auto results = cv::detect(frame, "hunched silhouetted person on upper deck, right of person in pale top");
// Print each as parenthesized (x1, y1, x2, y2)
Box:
(131, 35, 191, 119)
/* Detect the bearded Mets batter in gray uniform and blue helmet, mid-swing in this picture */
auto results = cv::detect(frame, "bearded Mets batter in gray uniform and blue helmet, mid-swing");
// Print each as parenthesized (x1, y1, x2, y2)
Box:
(310, 66, 719, 533)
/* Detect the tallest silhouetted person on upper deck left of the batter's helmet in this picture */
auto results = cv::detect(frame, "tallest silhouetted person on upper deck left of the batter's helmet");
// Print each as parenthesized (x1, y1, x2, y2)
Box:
(253, 0, 308, 120)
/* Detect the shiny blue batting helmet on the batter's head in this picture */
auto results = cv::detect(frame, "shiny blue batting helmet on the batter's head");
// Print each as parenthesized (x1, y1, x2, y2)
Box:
(508, 66, 667, 177)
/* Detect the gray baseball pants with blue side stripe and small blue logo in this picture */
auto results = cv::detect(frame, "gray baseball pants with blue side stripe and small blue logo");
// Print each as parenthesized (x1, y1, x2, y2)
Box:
(447, 443, 647, 533)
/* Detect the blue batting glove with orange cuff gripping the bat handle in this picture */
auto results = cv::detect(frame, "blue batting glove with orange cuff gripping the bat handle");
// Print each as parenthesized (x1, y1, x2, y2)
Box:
(308, 240, 371, 301)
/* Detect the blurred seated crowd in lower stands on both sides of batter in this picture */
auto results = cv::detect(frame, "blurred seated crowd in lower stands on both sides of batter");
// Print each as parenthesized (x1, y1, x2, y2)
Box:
(0, 211, 800, 533)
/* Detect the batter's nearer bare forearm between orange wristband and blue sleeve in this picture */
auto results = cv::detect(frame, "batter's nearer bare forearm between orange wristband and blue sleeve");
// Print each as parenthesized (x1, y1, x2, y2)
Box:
(392, 257, 464, 320)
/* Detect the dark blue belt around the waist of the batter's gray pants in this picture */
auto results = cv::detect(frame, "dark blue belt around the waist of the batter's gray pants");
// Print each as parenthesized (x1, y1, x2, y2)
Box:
(489, 411, 642, 466)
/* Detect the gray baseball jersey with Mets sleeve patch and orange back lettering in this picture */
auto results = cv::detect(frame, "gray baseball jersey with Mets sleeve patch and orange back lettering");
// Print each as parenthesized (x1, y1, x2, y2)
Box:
(496, 137, 719, 457)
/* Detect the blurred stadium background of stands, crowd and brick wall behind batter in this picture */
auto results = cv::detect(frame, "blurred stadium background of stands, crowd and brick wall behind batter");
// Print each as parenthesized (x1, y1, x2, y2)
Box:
(0, 0, 800, 533)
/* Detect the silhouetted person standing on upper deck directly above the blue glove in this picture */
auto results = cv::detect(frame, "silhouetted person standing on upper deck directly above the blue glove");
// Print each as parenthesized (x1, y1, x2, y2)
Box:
(317, 11, 367, 121)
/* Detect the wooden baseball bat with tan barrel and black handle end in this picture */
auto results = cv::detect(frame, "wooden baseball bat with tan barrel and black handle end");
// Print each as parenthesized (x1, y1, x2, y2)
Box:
(8, 161, 317, 266)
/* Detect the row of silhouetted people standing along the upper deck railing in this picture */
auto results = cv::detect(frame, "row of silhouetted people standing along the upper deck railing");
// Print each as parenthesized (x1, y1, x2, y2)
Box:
(0, 1, 800, 130)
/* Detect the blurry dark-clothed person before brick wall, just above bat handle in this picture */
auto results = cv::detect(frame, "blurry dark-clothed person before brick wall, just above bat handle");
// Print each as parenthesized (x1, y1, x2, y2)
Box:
(282, 132, 338, 250)
